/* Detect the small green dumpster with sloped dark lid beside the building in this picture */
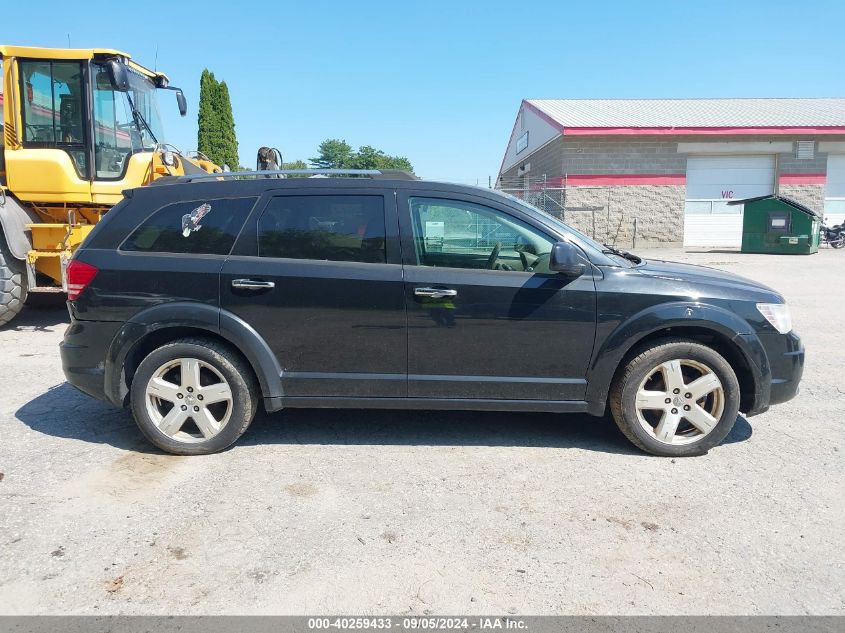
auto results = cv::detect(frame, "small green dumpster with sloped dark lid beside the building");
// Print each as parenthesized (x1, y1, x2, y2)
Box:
(728, 195, 821, 255)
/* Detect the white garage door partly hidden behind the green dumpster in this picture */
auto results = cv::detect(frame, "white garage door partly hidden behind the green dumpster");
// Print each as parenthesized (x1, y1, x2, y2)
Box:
(684, 155, 775, 246)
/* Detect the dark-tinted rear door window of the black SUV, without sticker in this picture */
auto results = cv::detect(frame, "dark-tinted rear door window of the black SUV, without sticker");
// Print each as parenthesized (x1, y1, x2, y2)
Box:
(258, 195, 387, 263)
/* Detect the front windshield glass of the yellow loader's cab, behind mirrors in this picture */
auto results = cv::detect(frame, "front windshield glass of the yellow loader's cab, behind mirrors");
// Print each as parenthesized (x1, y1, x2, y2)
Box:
(93, 64, 164, 179)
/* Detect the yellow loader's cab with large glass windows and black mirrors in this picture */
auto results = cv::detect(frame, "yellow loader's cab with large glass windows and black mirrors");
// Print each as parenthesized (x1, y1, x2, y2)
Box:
(0, 47, 186, 205)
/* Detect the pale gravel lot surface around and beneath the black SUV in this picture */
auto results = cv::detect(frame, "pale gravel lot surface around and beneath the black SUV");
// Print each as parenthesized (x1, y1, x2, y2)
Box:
(0, 250, 845, 614)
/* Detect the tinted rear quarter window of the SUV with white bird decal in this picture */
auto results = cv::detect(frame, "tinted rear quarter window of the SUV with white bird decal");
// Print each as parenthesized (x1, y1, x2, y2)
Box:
(121, 197, 256, 255)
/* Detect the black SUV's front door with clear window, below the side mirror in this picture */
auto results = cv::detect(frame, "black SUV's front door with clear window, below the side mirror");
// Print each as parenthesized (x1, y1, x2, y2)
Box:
(398, 190, 596, 401)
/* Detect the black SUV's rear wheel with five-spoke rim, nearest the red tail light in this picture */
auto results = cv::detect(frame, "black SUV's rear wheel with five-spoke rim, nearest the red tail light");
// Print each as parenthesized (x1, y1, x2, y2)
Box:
(131, 338, 259, 455)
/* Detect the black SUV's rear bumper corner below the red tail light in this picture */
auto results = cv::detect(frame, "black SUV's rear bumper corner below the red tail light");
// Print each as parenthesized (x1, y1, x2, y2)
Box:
(59, 320, 121, 400)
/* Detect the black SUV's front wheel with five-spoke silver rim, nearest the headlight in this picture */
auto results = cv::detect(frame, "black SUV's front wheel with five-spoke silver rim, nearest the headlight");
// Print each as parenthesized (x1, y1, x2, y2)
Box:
(610, 339, 740, 457)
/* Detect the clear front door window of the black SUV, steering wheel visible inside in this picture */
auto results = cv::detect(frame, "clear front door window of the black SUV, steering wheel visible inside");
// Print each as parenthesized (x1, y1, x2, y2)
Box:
(410, 197, 554, 272)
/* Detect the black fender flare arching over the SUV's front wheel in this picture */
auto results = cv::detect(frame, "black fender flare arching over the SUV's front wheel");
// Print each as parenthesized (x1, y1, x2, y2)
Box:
(587, 301, 771, 415)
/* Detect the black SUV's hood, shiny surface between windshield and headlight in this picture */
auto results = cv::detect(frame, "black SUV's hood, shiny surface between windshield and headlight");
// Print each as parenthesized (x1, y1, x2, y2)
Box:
(636, 259, 783, 302)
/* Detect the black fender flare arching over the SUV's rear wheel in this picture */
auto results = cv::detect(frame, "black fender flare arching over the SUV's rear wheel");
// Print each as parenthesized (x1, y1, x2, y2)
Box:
(104, 301, 282, 410)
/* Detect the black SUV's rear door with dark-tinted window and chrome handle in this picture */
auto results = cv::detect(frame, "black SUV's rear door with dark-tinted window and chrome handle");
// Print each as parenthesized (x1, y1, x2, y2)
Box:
(220, 186, 407, 398)
